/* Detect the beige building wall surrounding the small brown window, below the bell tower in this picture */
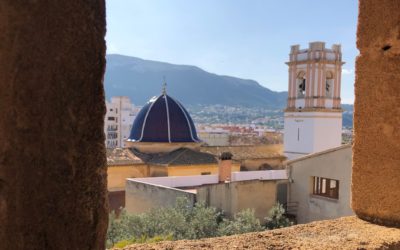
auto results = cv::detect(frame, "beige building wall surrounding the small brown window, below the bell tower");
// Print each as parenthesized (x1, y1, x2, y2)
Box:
(287, 145, 353, 223)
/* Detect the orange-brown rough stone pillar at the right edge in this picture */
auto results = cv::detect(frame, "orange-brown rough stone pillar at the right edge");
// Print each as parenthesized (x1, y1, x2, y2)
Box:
(352, 0, 400, 225)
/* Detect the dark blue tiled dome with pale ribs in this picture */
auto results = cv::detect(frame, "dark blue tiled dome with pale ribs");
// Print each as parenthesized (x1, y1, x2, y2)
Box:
(128, 93, 200, 142)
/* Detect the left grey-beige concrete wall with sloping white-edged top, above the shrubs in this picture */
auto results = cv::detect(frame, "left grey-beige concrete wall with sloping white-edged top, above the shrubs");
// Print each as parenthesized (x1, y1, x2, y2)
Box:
(125, 179, 196, 214)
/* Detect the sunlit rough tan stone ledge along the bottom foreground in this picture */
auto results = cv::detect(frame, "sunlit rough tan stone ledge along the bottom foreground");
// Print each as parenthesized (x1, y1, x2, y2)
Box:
(118, 216, 400, 250)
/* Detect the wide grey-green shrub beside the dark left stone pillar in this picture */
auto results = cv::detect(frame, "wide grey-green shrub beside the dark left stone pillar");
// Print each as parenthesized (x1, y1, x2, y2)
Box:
(107, 197, 219, 247)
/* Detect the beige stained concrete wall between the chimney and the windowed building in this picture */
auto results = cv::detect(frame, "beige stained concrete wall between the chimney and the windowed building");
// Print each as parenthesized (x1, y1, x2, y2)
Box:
(197, 180, 279, 221)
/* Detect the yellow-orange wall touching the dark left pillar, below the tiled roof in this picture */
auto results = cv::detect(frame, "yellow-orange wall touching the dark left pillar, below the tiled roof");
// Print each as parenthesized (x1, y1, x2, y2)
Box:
(107, 165, 148, 191)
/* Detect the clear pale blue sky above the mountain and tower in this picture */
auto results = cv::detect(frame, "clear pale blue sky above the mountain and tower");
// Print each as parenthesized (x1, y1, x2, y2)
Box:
(106, 0, 358, 103)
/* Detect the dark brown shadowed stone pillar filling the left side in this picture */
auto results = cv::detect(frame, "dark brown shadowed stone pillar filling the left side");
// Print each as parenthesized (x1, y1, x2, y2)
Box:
(0, 0, 107, 249)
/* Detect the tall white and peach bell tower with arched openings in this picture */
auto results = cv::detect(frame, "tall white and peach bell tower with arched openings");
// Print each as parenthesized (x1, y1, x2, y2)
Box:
(284, 42, 344, 160)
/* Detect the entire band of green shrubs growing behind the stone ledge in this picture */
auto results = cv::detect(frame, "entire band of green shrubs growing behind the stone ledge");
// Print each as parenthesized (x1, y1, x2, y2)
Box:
(107, 198, 291, 248)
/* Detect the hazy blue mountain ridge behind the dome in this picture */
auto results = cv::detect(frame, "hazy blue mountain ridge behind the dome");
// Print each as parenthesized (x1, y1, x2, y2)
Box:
(105, 54, 287, 109)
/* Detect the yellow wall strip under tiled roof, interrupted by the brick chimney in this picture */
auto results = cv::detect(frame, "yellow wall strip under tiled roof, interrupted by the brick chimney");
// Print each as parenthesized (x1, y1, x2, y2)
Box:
(168, 164, 240, 176)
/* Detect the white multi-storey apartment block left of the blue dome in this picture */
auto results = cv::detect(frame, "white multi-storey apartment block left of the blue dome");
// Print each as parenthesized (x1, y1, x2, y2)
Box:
(104, 96, 139, 148)
